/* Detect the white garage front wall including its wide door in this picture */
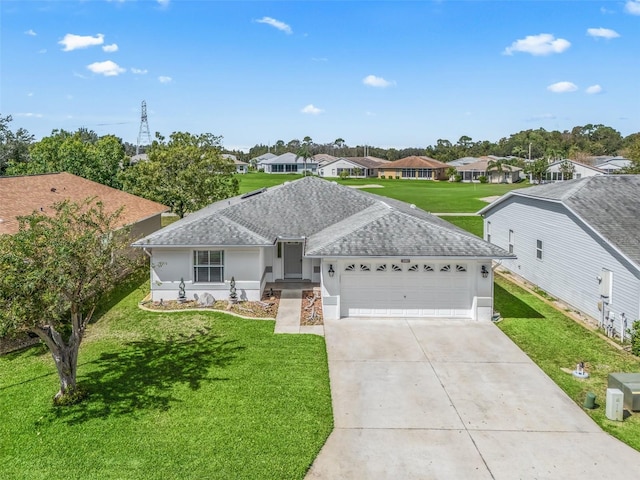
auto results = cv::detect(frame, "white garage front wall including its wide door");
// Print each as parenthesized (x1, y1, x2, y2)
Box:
(321, 258, 493, 320)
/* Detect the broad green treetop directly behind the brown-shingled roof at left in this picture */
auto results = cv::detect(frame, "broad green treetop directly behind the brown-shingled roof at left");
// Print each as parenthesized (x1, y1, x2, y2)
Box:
(7, 128, 127, 188)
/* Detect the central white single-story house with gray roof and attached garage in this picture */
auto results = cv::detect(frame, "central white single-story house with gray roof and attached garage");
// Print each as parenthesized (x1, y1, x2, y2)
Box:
(134, 176, 512, 321)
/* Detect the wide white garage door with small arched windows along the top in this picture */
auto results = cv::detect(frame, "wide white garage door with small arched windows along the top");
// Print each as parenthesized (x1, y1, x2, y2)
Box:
(340, 262, 473, 318)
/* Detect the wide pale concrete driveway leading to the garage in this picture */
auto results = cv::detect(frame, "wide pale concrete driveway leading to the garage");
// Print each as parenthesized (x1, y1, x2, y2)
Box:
(307, 319, 640, 480)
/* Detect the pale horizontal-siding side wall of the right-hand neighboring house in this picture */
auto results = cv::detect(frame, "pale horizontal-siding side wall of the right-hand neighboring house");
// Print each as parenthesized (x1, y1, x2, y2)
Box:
(485, 197, 640, 332)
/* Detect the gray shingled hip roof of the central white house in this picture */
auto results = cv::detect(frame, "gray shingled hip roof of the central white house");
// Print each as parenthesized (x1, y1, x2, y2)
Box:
(134, 177, 512, 258)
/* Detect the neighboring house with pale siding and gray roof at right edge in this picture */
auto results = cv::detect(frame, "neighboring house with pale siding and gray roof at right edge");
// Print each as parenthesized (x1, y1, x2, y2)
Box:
(480, 175, 640, 336)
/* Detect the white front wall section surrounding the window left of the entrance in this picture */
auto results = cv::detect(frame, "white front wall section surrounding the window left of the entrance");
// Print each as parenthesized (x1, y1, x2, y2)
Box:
(151, 247, 264, 301)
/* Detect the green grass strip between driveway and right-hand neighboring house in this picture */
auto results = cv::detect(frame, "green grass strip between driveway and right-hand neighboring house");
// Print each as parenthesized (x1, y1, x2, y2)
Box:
(494, 277, 640, 450)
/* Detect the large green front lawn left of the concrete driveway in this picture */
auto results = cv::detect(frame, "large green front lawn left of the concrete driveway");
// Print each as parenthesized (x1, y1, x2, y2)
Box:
(0, 282, 333, 479)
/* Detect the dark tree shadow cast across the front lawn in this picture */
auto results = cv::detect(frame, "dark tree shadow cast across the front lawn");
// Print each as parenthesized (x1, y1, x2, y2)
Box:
(50, 331, 245, 425)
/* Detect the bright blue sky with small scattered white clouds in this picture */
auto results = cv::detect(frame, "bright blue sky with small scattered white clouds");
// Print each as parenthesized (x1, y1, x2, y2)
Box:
(0, 0, 640, 149)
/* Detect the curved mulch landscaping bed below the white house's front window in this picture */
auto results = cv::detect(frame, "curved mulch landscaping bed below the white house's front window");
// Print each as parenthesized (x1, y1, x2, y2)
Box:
(140, 290, 280, 318)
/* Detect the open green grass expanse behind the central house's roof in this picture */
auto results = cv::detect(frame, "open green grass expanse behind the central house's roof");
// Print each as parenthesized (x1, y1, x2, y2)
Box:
(238, 172, 529, 213)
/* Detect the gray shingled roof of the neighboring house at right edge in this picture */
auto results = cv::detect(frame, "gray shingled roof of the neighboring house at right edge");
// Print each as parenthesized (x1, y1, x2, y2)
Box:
(480, 175, 640, 267)
